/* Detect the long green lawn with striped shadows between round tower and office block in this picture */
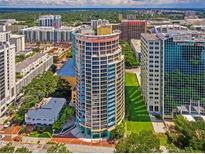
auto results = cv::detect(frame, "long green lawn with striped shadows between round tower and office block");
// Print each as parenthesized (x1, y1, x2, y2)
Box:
(125, 72, 153, 134)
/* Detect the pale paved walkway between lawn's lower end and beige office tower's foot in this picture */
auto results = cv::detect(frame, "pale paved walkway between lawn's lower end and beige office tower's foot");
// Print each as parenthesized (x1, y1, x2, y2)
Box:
(150, 114, 166, 133)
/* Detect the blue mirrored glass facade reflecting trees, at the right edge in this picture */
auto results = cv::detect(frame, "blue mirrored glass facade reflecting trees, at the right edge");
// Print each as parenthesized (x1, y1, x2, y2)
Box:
(164, 36, 205, 113)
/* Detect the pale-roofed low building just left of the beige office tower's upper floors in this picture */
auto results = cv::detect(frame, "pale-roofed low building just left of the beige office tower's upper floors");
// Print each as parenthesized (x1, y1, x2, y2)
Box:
(131, 39, 141, 62)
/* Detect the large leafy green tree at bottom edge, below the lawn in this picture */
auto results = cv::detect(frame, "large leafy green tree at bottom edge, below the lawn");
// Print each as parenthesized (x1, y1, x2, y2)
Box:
(116, 131, 160, 153)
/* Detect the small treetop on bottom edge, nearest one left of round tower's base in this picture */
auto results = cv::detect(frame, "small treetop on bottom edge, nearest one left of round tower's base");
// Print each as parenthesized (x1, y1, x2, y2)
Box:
(47, 144, 70, 153)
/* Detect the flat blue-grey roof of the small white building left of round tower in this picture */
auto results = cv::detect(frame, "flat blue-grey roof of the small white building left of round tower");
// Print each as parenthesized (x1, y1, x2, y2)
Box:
(27, 97, 66, 119)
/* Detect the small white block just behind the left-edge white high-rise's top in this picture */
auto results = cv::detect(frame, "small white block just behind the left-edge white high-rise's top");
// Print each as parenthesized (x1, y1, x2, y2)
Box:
(11, 35, 25, 52)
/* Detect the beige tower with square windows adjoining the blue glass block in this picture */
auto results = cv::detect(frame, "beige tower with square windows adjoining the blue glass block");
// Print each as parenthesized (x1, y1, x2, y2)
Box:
(141, 33, 162, 113)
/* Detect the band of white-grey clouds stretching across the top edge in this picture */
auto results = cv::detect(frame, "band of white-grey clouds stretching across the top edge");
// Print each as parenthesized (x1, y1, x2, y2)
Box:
(0, 0, 205, 7)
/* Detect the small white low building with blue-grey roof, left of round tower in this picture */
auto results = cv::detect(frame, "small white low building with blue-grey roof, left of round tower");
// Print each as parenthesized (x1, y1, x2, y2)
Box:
(25, 97, 66, 125)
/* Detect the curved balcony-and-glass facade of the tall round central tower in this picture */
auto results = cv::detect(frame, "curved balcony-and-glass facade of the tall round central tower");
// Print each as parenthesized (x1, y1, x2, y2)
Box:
(73, 32, 125, 138)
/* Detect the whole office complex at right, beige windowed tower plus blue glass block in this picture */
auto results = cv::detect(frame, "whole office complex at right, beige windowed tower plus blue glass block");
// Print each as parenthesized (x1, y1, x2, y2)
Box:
(141, 25, 205, 117)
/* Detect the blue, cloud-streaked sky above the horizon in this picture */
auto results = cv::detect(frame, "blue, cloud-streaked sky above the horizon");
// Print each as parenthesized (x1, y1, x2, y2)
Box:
(0, 0, 205, 8)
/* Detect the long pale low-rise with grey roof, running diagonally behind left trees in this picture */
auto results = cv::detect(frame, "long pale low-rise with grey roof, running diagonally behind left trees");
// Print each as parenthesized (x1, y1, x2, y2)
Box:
(16, 53, 53, 94)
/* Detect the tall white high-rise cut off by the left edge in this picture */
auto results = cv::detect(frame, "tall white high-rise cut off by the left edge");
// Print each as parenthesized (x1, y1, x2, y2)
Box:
(0, 32, 16, 116)
